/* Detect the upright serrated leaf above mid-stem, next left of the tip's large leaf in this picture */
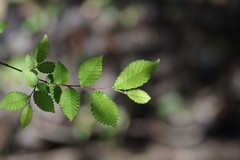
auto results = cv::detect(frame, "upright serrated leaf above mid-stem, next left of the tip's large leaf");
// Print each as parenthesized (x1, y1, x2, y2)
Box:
(78, 56, 103, 86)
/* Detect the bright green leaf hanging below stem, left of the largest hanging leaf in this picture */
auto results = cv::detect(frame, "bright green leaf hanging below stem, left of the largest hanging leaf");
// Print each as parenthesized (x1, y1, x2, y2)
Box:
(60, 88, 80, 121)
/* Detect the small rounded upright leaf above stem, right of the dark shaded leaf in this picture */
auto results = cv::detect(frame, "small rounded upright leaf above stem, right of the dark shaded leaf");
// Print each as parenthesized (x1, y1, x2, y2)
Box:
(53, 62, 69, 84)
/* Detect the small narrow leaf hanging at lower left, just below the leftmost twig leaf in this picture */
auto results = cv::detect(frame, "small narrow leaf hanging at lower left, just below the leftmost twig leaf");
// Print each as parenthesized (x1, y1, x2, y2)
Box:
(20, 104, 33, 128)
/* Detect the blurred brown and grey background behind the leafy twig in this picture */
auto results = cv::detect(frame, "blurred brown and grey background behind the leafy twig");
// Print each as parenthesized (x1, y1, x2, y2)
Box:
(0, 0, 240, 160)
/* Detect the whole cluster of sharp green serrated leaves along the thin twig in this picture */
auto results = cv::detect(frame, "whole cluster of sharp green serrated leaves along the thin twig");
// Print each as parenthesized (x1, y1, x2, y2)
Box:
(0, 21, 159, 128)
